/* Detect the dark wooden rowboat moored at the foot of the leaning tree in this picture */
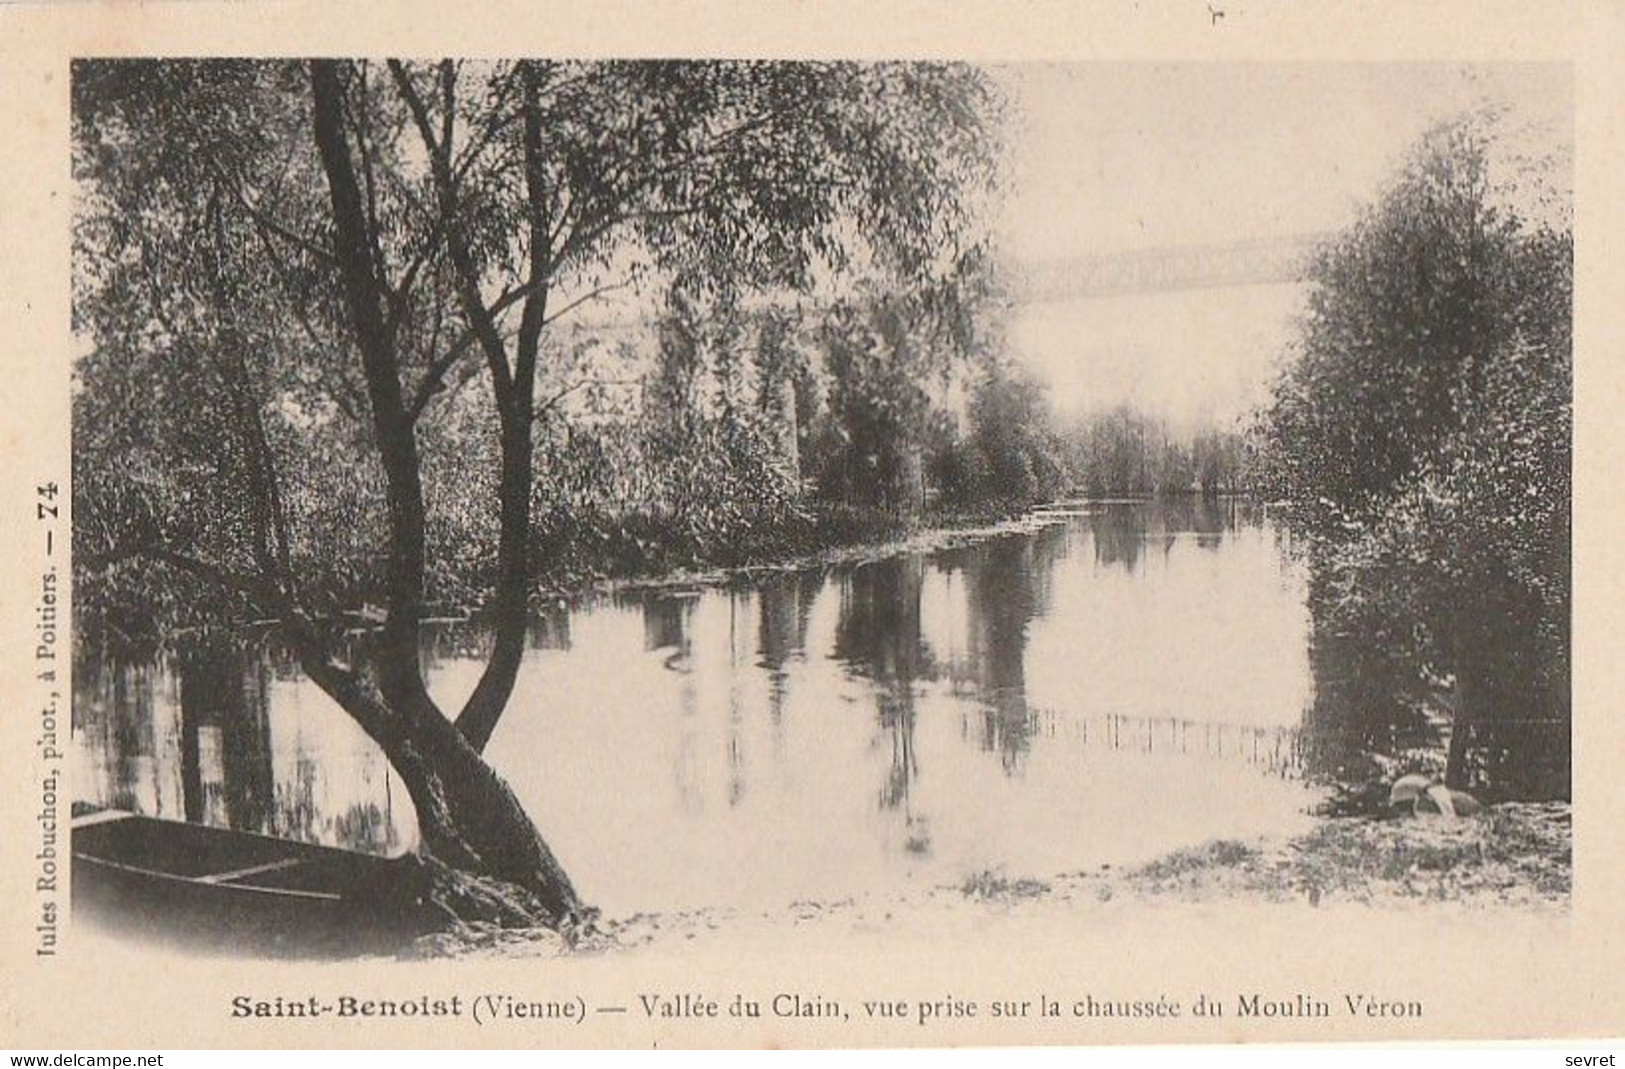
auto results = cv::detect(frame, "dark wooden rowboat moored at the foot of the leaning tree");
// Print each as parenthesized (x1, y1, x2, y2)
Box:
(73, 811, 440, 957)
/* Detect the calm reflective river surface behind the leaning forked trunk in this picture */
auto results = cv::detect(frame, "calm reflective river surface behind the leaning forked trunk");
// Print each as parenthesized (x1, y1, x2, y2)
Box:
(75, 500, 1311, 913)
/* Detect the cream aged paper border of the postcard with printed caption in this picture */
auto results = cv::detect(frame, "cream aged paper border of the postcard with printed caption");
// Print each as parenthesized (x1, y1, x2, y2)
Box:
(0, 2, 1625, 1048)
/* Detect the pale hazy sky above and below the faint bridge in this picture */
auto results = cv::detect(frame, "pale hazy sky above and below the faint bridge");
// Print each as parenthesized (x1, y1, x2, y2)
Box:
(998, 63, 1571, 424)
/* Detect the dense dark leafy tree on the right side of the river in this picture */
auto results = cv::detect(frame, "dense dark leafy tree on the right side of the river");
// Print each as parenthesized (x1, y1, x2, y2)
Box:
(1263, 119, 1573, 796)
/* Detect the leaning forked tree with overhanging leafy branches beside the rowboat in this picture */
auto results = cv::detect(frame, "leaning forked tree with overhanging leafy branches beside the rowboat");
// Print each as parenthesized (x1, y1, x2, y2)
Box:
(73, 60, 999, 923)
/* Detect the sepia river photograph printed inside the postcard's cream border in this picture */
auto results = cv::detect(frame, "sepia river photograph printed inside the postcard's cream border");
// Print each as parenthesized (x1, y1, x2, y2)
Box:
(63, 51, 1571, 952)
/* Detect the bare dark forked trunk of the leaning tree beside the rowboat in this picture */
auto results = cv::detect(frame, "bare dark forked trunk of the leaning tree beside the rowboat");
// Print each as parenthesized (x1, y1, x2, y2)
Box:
(301, 60, 580, 923)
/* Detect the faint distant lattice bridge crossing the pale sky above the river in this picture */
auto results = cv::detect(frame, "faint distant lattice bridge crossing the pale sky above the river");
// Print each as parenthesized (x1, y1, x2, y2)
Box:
(1014, 232, 1331, 304)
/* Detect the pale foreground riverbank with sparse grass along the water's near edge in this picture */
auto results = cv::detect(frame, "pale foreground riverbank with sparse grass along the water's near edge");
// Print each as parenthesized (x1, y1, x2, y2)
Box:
(406, 803, 1573, 959)
